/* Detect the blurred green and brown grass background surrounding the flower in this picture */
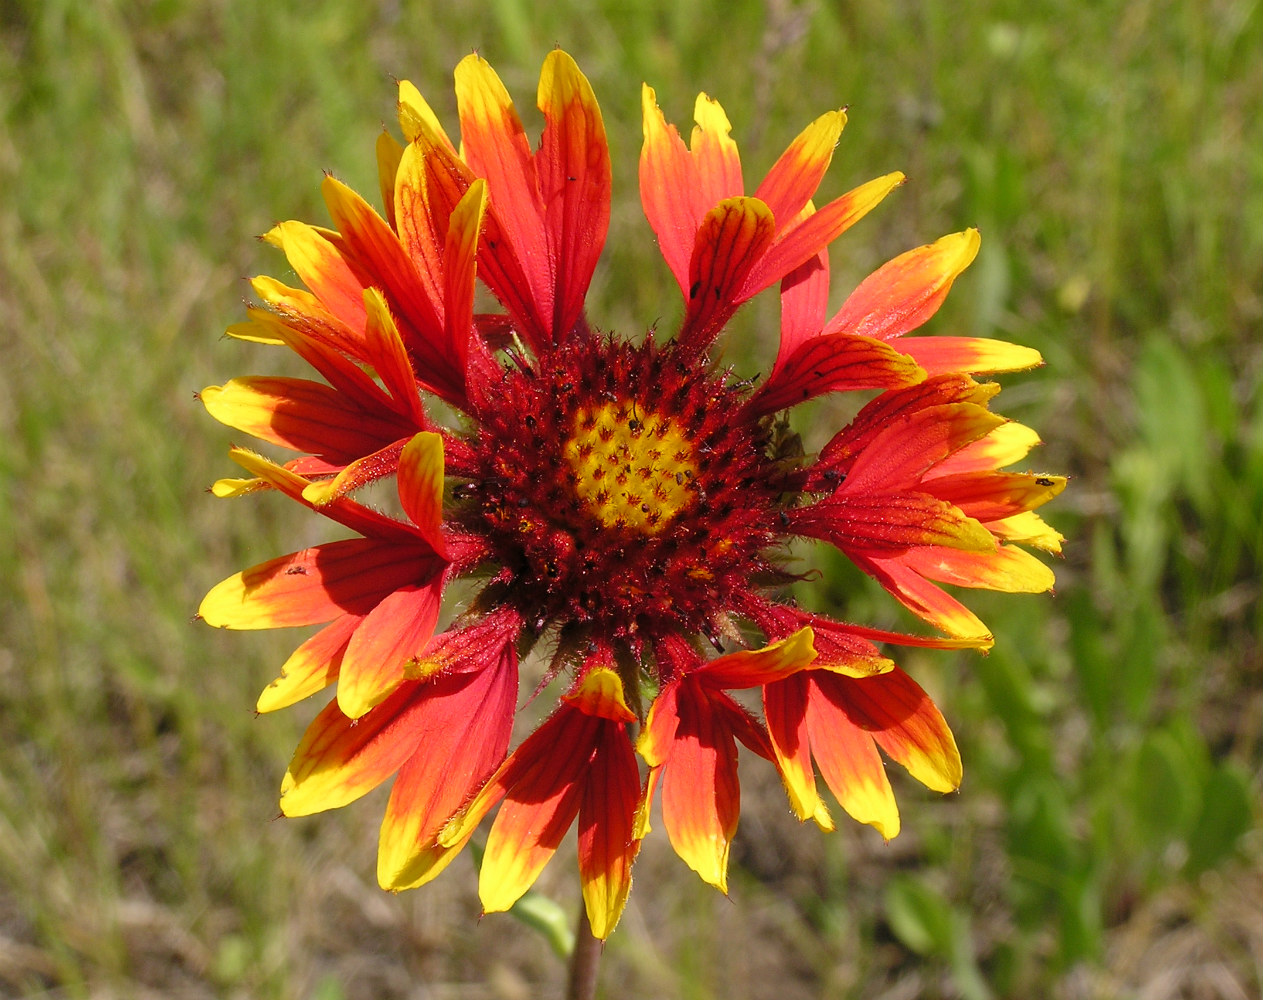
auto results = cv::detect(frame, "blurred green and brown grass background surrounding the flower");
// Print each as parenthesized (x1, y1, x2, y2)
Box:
(0, 0, 1263, 1000)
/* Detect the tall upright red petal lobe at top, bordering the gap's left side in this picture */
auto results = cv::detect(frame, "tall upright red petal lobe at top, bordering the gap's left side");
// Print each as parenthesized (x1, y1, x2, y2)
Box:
(536, 49, 611, 338)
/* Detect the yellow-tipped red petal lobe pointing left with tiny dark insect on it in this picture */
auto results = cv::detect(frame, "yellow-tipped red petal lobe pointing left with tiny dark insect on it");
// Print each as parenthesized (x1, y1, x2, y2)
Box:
(197, 538, 424, 629)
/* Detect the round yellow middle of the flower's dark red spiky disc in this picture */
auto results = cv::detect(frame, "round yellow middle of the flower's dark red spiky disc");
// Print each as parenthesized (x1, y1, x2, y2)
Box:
(562, 400, 697, 535)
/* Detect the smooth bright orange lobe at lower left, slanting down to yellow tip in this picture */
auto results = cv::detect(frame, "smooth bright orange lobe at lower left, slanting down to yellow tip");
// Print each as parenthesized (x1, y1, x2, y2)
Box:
(337, 570, 445, 718)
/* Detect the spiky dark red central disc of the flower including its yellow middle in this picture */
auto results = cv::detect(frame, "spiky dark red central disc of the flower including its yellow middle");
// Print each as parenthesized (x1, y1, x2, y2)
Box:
(458, 338, 786, 640)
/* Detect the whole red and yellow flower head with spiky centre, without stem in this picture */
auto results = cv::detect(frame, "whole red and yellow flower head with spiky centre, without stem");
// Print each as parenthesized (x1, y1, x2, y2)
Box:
(200, 51, 1065, 938)
